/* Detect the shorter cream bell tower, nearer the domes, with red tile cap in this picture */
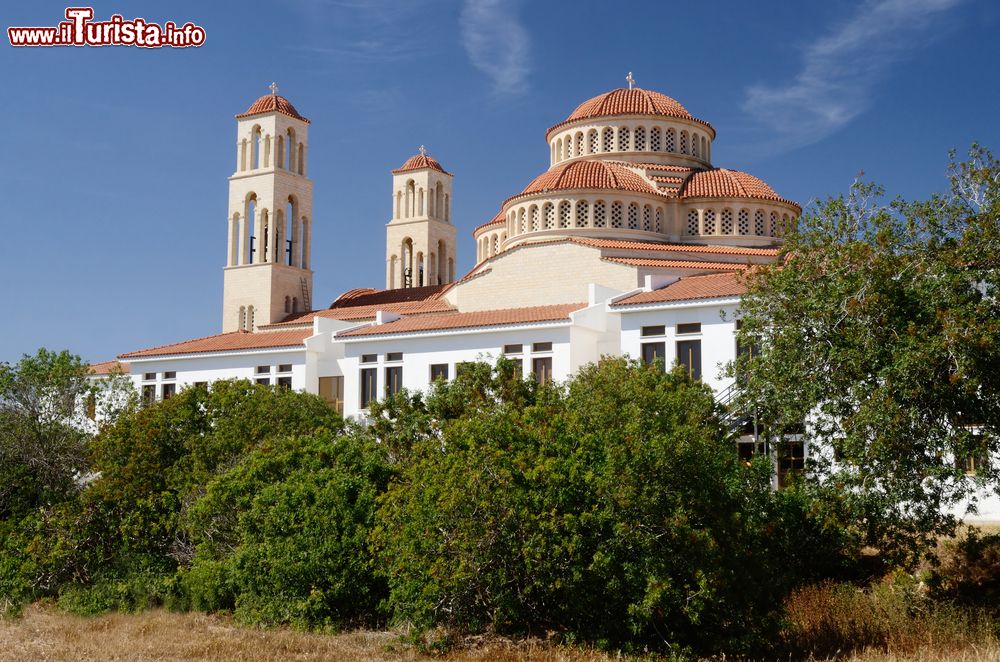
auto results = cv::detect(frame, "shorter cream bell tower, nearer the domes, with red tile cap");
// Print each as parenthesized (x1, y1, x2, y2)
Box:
(385, 150, 455, 290)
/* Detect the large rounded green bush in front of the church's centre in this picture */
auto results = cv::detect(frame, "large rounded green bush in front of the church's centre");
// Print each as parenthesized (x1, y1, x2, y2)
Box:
(373, 359, 841, 651)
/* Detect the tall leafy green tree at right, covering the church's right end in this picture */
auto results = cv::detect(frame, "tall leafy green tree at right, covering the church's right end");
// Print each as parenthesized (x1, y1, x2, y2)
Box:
(735, 145, 1000, 560)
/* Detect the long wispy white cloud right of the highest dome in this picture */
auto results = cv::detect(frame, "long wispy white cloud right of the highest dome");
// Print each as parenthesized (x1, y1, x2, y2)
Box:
(743, 0, 964, 151)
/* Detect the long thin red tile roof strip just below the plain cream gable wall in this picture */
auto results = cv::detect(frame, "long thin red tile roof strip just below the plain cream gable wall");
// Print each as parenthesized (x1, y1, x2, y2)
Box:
(337, 303, 587, 337)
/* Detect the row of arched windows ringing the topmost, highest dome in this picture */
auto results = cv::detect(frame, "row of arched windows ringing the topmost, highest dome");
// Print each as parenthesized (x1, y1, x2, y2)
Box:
(550, 126, 711, 163)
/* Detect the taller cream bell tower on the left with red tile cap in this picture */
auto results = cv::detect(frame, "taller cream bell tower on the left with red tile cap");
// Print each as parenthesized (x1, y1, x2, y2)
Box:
(222, 83, 312, 332)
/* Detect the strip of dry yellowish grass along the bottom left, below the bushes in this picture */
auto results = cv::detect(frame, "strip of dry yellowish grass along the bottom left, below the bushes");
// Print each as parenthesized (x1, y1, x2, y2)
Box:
(0, 604, 617, 662)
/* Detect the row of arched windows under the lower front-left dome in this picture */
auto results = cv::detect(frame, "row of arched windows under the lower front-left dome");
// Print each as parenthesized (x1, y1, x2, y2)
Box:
(507, 200, 664, 236)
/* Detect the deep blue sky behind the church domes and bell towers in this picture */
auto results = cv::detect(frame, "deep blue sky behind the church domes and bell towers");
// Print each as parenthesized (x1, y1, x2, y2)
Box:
(0, 0, 1000, 361)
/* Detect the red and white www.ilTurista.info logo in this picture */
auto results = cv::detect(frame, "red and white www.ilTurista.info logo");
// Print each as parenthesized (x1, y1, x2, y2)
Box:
(7, 7, 205, 48)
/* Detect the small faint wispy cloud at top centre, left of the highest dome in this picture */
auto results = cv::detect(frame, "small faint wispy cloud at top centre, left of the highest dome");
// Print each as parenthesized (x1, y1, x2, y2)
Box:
(460, 0, 531, 94)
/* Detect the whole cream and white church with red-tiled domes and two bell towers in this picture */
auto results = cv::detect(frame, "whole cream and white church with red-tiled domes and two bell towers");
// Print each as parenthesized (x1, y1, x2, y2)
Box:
(86, 80, 1000, 517)
